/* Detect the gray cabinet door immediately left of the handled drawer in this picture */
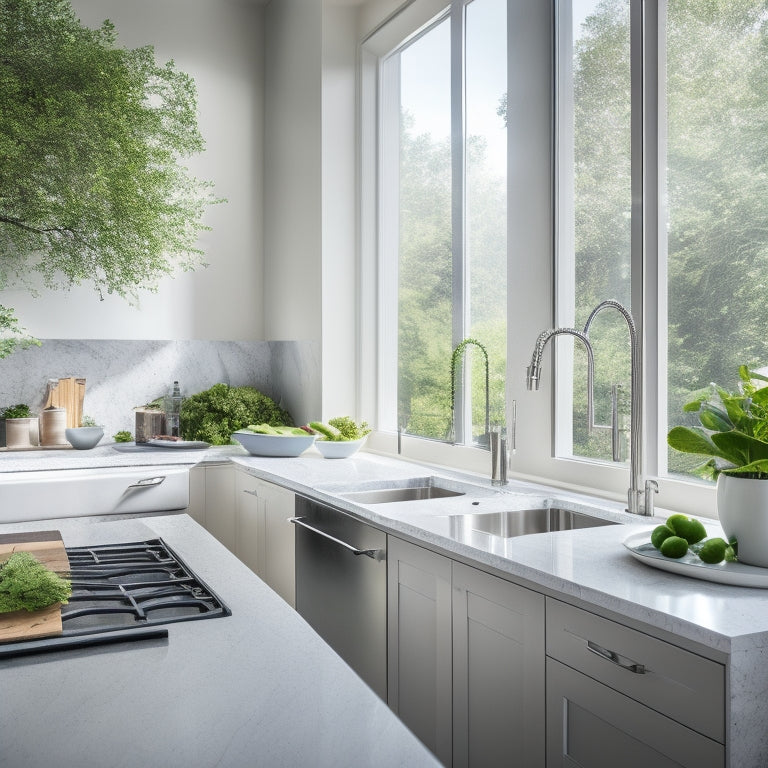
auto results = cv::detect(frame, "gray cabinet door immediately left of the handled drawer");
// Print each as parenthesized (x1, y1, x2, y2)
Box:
(453, 563, 546, 768)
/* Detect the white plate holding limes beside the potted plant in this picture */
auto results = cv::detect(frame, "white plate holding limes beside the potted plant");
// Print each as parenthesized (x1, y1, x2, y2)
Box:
(624, 531, 768, 589)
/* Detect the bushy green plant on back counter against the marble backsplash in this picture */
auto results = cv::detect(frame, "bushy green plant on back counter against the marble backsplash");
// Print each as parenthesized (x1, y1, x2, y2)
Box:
(179, 384, 293, 445)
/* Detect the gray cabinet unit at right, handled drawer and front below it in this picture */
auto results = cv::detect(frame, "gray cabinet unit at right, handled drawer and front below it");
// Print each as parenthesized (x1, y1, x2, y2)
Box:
(546, 598, 725, 768)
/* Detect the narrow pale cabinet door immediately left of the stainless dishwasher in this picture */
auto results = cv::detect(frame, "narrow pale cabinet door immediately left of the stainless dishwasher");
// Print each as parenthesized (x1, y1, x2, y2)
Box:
(258, 481, 296, 607)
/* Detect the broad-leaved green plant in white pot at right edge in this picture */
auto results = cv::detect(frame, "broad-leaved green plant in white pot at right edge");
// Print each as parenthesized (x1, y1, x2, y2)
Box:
(667, 365, 768, 568)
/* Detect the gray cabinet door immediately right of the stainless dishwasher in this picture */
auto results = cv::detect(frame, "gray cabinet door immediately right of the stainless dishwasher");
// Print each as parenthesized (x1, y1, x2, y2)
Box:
(387, 536, 453, 765)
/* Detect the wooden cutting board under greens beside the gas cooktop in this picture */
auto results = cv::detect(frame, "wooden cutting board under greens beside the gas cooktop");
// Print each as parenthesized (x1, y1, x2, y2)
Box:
(0, 531, 69, 643)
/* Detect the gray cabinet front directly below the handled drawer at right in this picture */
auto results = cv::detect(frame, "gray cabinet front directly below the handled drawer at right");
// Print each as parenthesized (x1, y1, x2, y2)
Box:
(547, 658, 725, 768)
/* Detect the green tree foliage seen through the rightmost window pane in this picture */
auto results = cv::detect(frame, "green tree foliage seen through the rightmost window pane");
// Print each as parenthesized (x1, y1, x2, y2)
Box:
(667, 0, 768, 428)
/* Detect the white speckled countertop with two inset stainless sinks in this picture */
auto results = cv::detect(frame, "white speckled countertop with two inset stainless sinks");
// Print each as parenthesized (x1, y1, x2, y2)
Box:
(226, 452, 768, 653)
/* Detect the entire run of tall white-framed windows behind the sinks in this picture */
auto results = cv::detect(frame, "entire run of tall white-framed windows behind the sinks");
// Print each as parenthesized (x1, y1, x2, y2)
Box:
(363, 0, 768, 512)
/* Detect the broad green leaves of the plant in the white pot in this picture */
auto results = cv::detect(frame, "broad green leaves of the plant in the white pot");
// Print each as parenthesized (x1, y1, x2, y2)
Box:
(667, 365, 768, 480)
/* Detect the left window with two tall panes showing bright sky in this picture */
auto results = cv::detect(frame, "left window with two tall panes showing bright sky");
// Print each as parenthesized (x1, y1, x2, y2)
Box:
(379, 0, 507, 445)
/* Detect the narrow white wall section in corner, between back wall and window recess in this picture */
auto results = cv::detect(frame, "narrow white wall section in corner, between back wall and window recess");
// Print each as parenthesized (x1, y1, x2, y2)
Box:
(264, 0, 322, 341)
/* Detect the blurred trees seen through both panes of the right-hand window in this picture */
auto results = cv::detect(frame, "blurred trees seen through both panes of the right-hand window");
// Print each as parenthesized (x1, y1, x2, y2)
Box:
(556, 0, 768, 475)
